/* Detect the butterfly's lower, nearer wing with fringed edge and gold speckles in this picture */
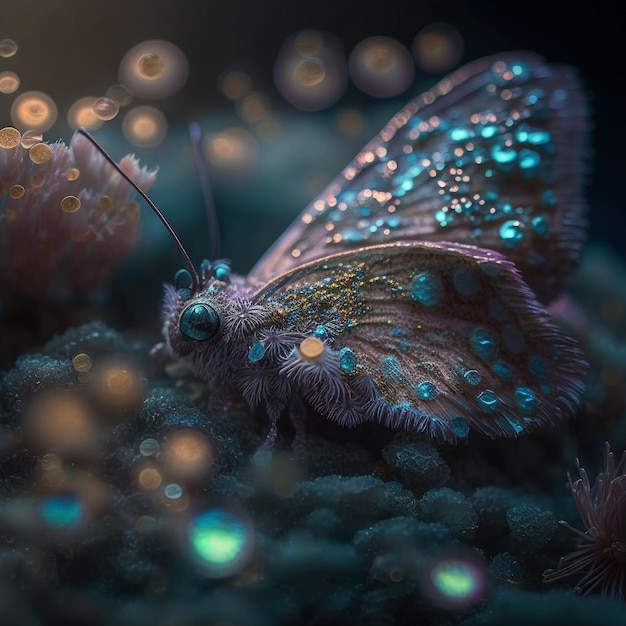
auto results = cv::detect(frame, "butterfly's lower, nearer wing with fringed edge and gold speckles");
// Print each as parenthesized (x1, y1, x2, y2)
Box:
(253, 243, 585, 441)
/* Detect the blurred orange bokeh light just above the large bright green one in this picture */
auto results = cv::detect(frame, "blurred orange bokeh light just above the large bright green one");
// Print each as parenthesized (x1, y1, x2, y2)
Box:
(162, 428, 215, 482)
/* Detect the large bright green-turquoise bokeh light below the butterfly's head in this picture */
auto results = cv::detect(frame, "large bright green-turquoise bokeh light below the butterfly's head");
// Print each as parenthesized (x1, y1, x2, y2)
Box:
(187, 508, 254, 578)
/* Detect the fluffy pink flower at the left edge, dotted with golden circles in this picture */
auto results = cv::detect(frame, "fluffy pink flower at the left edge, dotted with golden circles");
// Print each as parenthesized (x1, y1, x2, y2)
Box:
(0, 128, 156, 298)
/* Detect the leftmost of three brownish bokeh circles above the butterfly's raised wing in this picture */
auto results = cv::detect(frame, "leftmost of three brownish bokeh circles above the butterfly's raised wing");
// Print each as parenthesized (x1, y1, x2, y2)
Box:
(274, 30, 347, 111)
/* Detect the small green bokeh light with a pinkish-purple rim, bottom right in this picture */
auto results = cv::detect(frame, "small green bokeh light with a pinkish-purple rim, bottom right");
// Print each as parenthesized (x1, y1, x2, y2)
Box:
(421, 555, 487, 610)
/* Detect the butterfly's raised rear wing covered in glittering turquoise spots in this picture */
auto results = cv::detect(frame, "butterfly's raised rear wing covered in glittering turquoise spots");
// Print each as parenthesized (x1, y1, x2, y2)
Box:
(249, 52, 586, 300)
